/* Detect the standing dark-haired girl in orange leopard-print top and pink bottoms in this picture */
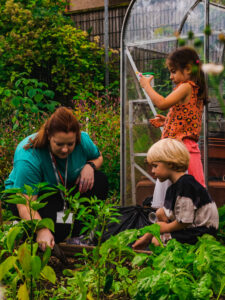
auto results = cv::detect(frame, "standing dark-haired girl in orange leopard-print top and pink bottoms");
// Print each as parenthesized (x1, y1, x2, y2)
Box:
(140, 47, 206, 207)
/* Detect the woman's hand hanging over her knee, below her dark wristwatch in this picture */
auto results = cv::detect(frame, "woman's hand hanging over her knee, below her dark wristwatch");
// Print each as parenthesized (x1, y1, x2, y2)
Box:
(76, 164, 94, 194)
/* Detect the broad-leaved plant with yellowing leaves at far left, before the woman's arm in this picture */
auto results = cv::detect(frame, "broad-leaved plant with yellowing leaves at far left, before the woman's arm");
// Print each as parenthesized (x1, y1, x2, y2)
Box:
(0, 183, 56, 299)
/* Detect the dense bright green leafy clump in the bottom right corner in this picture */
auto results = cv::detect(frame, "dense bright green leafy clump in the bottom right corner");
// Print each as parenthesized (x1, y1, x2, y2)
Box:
(132, 235, 225, 299)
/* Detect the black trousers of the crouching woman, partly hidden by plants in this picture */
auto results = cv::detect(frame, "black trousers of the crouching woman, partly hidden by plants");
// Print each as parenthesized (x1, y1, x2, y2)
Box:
(10, 170, 108, 243)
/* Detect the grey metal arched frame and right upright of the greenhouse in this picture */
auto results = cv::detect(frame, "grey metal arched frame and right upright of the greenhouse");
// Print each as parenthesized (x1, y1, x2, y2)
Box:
(120, 0, 221, 206)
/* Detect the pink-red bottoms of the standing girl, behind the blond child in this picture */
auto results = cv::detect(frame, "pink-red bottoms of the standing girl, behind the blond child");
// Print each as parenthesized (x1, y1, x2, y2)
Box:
(182, 139, 206, 187)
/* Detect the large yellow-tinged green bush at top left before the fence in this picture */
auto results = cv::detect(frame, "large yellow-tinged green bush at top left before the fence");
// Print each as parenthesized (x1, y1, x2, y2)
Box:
(0, 0, 118, 105)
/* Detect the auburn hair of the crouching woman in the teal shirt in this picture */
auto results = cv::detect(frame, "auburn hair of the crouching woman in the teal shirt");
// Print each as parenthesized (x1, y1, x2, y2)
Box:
(24, 106, 81, 150)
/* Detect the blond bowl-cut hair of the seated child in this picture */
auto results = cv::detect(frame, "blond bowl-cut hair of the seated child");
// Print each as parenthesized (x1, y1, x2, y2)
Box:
(147, 138, 190, 171)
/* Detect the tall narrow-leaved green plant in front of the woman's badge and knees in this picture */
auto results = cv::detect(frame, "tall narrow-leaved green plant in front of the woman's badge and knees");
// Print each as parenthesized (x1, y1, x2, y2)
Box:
(52, 192, 121, 299)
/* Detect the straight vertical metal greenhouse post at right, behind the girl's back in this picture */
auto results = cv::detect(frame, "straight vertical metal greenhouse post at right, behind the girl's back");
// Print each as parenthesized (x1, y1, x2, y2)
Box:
(203, 0, 209, 188)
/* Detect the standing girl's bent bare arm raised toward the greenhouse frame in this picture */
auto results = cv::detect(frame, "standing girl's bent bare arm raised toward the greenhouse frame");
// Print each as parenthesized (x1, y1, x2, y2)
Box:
(140, 76, 192, 110)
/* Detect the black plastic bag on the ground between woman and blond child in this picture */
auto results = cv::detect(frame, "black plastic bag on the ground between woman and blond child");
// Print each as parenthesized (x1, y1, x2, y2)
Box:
(102, 205, 155, 242)
